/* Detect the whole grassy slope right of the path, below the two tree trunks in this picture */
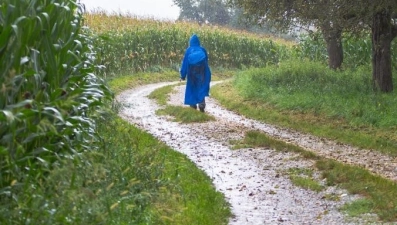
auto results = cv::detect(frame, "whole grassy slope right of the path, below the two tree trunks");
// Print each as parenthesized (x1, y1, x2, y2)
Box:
(212, 61, 397, 156)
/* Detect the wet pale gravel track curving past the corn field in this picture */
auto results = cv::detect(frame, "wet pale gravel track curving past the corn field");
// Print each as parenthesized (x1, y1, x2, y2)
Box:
(117, 83, 397, 225)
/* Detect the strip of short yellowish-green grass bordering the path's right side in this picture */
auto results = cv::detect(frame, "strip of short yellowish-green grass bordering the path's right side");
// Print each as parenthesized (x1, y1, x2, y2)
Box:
(212, 77, 397, 156)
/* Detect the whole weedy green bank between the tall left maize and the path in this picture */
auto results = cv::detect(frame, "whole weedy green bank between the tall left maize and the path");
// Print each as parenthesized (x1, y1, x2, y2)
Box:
(0, 114, 230, 225)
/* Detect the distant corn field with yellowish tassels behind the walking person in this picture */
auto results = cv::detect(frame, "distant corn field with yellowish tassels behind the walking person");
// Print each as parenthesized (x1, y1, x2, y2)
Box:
(85, 12, 291, 76)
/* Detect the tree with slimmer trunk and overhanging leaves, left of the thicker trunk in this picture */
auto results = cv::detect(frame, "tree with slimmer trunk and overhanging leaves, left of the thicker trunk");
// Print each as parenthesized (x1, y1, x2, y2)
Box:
(229, 0, 350, 69)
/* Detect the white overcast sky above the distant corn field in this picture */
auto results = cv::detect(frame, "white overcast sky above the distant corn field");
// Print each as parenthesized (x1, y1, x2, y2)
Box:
(80, 0, 179, 20)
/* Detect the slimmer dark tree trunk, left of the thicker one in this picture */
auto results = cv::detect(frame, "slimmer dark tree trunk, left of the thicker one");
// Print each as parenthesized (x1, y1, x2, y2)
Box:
(322, 23, 343, 70)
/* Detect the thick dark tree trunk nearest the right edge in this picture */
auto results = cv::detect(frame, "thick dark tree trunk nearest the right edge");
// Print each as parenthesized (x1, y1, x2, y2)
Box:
(372, 10, 395, 92)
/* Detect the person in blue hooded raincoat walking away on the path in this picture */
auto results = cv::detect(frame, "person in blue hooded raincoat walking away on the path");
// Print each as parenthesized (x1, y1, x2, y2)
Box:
(180, 34, 211, 112)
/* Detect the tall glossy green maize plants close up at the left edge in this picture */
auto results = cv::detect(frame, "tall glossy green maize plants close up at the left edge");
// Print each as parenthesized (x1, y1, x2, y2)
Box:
(0, 0, 111, 188)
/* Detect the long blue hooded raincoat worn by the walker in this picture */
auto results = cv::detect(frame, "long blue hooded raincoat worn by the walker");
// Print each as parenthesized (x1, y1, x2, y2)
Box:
(180, 34, 211, 105)
